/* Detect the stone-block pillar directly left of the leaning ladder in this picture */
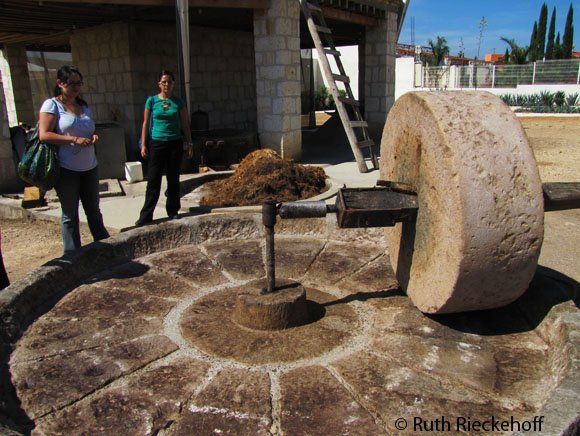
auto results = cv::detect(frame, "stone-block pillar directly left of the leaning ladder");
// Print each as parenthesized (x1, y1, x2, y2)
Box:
(254, 0, 302, 159)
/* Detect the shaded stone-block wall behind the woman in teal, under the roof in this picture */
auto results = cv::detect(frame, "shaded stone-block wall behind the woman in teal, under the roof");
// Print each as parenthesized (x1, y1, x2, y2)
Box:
(70, 22, 256, 157)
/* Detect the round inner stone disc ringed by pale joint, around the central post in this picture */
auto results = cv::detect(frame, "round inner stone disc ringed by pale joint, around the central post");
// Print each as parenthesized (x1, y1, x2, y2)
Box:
(178, 279, 362, 365)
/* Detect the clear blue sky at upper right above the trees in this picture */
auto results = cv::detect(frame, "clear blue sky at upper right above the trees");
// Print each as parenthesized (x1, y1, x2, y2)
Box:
(399, 0, 580, 58)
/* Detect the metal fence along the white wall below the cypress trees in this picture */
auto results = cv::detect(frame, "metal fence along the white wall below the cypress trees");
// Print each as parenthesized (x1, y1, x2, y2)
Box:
(422, 59, 580, 89)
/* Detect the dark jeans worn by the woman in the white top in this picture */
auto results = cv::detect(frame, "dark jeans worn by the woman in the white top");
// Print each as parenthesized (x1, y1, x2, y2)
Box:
(55, 167, 109, 254)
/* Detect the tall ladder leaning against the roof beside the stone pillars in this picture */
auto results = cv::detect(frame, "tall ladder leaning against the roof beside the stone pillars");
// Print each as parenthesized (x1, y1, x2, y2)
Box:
(299, 0, 379, 173)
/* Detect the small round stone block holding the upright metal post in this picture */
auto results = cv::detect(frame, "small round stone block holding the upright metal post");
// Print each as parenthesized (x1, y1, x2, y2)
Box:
(233, 280, 308, 330)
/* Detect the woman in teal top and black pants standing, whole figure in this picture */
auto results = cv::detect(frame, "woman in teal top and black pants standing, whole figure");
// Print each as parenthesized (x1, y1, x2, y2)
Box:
(135, 70, 193, 226)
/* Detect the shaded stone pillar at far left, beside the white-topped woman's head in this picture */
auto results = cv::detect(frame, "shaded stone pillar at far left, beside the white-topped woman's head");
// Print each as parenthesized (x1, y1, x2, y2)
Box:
(0, 45, 35, 126)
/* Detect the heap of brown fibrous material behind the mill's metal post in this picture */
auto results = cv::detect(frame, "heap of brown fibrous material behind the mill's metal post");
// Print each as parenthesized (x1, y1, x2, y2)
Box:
(201, 149, 327, 207)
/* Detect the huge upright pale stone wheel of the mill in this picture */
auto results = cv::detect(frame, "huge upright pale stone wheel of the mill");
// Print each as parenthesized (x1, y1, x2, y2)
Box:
(381, 92, 544, 313)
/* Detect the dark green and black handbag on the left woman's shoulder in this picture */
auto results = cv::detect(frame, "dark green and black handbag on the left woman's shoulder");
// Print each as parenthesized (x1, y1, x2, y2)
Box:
(18, 124, 60, 191)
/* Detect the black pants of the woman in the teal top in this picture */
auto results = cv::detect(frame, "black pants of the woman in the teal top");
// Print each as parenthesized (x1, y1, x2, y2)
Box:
(139, 139, 183, 222)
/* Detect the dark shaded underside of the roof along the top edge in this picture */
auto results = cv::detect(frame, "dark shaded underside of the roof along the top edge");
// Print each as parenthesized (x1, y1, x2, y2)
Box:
(0, 0, 403, 51)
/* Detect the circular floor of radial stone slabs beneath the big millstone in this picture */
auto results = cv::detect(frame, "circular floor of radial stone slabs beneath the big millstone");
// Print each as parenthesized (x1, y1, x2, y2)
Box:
(4, 215, 577, 435)
